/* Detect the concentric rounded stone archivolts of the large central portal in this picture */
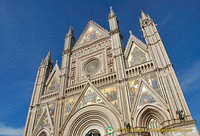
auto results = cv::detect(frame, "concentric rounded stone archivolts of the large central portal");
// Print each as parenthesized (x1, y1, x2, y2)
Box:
(60, 104, 122, 136)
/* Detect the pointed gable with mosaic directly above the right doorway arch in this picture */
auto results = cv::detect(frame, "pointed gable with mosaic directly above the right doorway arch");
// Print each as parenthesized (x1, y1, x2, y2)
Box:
(131, 78, 167, 115)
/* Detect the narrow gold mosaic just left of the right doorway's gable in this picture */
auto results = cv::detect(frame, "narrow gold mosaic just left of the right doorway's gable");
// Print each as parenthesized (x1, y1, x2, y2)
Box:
(129, 80, 139, 104)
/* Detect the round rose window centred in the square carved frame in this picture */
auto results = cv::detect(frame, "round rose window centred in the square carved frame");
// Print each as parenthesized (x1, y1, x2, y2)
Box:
(85, 59, 100, 74)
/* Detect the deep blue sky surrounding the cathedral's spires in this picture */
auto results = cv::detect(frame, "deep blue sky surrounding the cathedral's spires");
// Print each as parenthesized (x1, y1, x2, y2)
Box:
(0, 0, 200, 136)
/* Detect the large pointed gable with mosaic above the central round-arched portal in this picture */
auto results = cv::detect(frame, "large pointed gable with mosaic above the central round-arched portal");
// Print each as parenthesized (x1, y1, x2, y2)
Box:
(61, 80, 120, 128)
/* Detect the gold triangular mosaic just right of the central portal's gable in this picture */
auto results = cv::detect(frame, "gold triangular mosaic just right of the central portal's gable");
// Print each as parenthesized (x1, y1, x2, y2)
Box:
(101, 86, 119, 109)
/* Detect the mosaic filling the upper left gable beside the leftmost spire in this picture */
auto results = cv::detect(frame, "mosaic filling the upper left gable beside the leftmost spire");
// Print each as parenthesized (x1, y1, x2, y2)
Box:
(46, 73, 60, 94)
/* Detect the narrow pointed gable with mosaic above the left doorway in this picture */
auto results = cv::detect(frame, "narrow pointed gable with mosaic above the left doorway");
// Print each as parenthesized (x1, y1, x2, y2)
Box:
(34, 104, 54, 133)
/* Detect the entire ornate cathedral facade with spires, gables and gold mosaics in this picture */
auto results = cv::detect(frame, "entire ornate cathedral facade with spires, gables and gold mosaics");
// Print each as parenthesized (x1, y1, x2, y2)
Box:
(24, 8, 199, 136)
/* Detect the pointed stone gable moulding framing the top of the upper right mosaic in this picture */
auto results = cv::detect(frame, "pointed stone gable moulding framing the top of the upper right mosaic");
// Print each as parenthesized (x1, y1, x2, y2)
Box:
(124, 33, 147, 58)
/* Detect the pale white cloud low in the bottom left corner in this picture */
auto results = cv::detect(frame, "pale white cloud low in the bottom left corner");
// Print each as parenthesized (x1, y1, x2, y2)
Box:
(0, 123, 24, 136)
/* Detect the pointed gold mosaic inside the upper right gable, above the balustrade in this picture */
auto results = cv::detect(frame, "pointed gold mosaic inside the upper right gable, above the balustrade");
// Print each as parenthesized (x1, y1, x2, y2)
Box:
(128, 45, 147, 66)
